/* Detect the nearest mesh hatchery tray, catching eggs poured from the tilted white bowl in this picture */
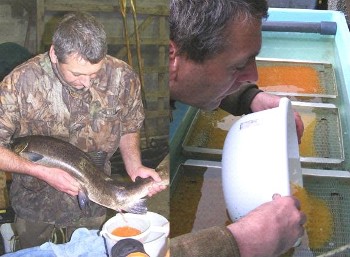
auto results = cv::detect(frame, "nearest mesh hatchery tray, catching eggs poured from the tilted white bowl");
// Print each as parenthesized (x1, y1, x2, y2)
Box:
(170, 163, 350, 257)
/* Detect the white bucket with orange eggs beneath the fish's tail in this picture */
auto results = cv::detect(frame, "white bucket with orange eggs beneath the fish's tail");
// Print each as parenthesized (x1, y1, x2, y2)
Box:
(101, 212, 170, 257)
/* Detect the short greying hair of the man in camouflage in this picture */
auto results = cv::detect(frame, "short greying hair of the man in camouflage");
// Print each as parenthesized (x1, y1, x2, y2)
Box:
(52, 12, 107, 63)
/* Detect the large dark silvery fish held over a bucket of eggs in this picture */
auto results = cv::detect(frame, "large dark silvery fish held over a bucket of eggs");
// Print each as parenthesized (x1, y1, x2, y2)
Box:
(11, 136, 169, 214)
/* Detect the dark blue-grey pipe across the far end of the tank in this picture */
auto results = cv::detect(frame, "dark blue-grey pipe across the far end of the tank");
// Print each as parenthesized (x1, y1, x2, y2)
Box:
(262, 21, 337, 35)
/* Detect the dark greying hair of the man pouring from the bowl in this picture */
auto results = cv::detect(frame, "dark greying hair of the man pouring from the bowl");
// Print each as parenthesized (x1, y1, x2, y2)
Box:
(169, 0, 268, 63)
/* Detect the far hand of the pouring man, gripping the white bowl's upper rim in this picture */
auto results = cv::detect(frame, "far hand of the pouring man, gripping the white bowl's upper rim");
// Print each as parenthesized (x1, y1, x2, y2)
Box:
(250, 92, 304, 144)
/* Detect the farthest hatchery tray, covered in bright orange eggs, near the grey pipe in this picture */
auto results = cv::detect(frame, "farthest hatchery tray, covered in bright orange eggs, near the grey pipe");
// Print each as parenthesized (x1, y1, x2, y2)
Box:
(256, 58, 338, 98)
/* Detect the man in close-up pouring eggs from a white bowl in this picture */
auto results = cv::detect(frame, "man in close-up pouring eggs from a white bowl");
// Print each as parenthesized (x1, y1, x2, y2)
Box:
(169, 0, 306, 257)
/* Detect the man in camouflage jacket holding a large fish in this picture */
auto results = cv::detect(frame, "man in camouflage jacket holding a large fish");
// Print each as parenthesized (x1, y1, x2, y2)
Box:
(0, 13, 164, 248)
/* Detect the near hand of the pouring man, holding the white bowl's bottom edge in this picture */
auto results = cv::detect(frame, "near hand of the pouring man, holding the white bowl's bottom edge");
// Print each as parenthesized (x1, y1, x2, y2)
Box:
(227, 195, 306, 257)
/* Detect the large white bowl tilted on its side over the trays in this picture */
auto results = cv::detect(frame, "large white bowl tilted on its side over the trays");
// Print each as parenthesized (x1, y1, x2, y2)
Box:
(222, 98, 302, 220)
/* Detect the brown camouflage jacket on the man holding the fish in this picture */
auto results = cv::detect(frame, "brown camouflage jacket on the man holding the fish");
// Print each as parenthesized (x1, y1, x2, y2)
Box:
(0, 53, 144, 226)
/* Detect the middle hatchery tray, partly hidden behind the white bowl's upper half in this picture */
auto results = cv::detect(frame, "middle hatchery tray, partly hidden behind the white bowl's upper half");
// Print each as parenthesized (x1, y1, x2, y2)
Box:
(182, 102, 344, 165)
